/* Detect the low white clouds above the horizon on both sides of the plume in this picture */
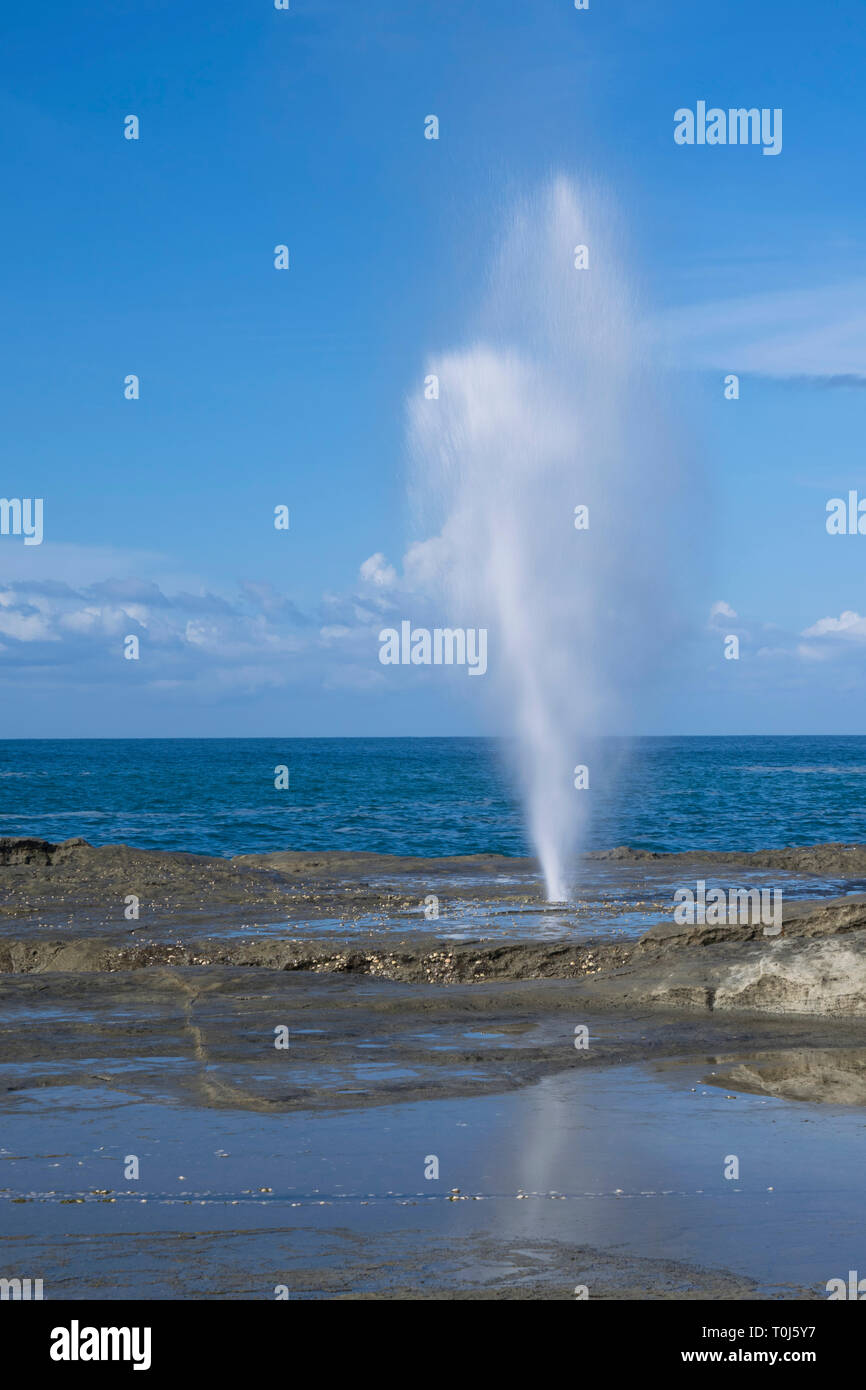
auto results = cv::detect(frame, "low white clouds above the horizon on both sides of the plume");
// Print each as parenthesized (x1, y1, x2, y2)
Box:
(0, 537, 866, 717)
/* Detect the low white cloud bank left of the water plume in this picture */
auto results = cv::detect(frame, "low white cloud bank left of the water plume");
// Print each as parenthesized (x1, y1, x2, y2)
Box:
(0, 536, 450, 698)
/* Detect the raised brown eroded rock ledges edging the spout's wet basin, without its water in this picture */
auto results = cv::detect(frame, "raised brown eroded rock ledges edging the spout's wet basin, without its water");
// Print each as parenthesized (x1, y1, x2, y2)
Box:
(0, 840, 866, 1017)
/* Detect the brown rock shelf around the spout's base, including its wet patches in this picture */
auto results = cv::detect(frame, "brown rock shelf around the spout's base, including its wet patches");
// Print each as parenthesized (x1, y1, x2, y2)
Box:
(6, 838, 866, 1017)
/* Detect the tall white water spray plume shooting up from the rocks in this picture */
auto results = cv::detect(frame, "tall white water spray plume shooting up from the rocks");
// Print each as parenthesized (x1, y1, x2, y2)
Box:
(410, 179, 683, 901)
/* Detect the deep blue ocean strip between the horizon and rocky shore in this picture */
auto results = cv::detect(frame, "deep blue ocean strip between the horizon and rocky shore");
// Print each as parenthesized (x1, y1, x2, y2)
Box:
(0, 735, 866, 856)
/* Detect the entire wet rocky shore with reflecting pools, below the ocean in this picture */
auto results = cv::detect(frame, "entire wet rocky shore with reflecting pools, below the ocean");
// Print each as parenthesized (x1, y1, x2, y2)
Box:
(0, 841, 866, 1298)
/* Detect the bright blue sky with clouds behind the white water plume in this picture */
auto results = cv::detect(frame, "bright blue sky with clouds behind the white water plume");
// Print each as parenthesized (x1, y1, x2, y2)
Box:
(0, 0, 866, 737)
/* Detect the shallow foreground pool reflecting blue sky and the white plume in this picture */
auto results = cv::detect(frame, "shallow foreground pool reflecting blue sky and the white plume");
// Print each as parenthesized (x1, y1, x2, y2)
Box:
(0, 1049, 866, 1297)
